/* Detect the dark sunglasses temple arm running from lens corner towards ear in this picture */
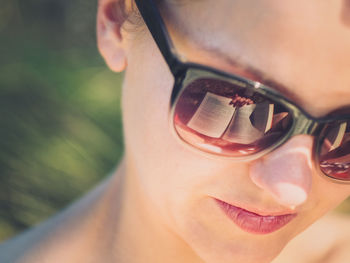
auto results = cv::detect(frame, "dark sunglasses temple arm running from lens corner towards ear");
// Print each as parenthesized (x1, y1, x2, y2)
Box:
(135, 0, 183, 76)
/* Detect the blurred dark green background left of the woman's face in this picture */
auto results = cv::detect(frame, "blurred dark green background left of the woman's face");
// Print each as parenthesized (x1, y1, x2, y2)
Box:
(0, 0, 350, 244)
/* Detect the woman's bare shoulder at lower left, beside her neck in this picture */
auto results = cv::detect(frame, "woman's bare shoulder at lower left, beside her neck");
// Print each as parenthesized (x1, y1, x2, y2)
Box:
(0, 175, 120, 263)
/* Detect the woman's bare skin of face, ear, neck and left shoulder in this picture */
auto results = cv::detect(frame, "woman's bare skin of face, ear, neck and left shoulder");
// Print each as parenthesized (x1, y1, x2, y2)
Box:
(0, 0, 350, 263)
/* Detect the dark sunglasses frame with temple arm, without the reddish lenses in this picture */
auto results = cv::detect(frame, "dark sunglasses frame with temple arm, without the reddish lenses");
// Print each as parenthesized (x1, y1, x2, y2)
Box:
(135, 0, 350, 184)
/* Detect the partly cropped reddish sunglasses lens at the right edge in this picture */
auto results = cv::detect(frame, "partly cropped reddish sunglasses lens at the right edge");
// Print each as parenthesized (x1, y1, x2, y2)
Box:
(319, 121, 350, 181)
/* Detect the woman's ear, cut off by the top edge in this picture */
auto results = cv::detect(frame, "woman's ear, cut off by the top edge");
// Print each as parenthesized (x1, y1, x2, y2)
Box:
(97, 0, 127, 72)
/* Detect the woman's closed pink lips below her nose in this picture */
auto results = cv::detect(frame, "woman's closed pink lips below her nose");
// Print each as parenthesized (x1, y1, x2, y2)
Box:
(215, 199, 297, 235)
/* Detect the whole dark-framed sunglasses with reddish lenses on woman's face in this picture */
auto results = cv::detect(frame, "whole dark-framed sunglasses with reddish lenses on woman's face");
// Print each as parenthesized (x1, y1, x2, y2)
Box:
(135, 0, 350, 183)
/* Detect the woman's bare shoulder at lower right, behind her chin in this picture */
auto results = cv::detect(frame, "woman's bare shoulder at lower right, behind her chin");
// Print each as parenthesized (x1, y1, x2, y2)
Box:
(273, 212, 350, 263)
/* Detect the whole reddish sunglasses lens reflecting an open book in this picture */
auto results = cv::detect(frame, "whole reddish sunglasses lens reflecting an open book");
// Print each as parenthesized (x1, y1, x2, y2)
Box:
(174, 78, 292, 156)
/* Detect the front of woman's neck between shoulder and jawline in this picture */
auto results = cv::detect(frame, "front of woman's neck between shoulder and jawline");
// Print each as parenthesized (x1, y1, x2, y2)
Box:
(111, 158, 203, 263)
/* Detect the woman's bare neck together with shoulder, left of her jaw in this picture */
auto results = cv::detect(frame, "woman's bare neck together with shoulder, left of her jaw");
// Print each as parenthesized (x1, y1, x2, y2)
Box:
(0, 160, 202, 263)
